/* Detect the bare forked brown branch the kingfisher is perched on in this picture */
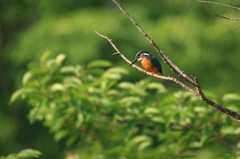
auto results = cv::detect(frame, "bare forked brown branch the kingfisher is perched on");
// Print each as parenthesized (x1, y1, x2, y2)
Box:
(96, 0, 240, 122)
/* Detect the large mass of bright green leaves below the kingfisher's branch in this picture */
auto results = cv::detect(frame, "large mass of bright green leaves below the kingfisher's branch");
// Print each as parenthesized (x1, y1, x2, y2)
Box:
(10, 53, 240, 159)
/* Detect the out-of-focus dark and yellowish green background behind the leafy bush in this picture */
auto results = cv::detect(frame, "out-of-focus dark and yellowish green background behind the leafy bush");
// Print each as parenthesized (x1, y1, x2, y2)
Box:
(0, 0, 240, 158)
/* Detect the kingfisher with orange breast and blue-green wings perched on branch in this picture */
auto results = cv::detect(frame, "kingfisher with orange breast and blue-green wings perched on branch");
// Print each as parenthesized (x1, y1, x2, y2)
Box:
(130, 50, 163, 76)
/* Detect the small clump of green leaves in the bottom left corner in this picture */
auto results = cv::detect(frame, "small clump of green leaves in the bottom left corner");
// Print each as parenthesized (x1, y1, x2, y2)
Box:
(0, 149, 41, 159)
